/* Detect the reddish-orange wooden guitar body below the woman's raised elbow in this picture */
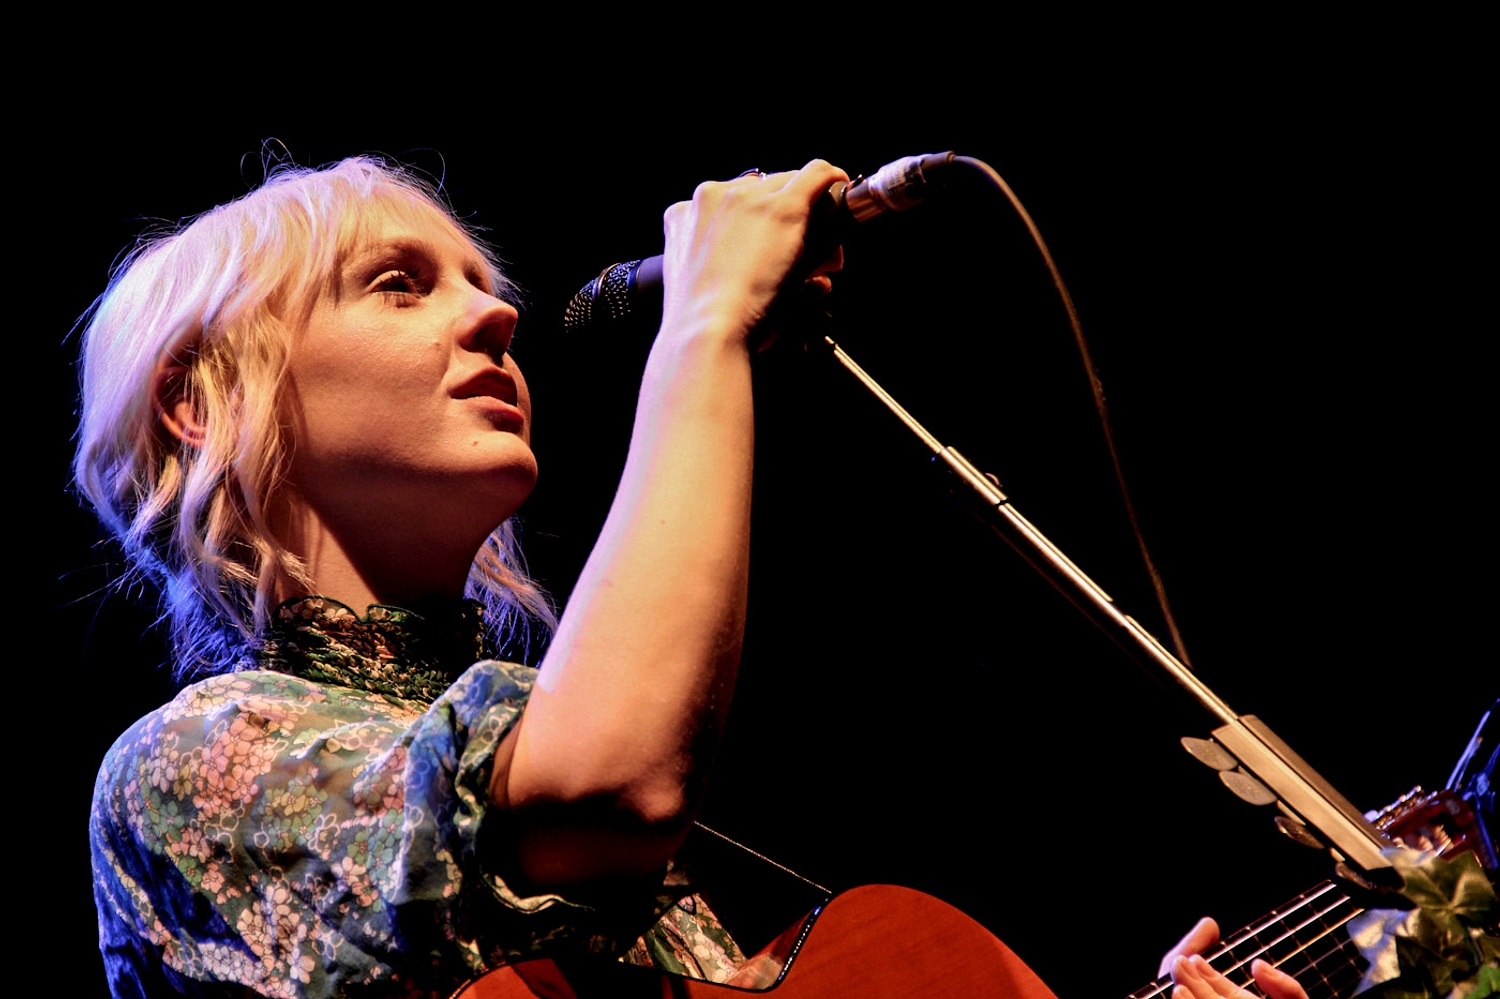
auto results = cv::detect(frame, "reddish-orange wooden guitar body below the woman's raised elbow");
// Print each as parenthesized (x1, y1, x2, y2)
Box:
(453, 885, 1056, 999)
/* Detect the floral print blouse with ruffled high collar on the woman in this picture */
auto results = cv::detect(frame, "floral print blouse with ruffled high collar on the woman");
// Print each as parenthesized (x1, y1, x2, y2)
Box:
(90, 597, 744, 999)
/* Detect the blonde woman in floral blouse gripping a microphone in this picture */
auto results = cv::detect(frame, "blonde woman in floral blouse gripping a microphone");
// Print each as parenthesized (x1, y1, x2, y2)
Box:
(75, 150, 1308, 998)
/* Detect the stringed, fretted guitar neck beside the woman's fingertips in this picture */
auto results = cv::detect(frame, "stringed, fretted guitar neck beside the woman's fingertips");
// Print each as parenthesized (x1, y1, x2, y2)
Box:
(1127, 881, 1364, 999)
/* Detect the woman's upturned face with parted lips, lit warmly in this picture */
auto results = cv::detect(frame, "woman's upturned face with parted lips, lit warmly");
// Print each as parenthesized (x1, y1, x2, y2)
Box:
(282, 210, 537, 537)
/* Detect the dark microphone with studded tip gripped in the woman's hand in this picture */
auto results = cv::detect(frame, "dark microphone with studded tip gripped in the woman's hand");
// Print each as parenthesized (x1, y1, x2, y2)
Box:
(563, 152, 954, 332)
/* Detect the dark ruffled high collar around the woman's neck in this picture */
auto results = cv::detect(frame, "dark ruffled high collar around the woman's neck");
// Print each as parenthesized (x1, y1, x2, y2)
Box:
(239, 597, 485, 704)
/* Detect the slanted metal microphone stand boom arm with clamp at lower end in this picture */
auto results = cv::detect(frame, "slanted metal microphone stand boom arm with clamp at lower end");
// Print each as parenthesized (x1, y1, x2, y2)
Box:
(807, 327, 1400, 887)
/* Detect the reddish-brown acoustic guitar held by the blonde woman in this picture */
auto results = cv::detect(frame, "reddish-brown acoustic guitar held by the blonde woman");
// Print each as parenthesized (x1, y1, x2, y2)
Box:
(453, 702, 1500, 999)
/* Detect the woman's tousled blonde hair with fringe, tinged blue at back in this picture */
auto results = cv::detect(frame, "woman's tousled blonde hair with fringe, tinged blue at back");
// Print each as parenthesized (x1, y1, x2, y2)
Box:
(74, 158, 555, 677)
